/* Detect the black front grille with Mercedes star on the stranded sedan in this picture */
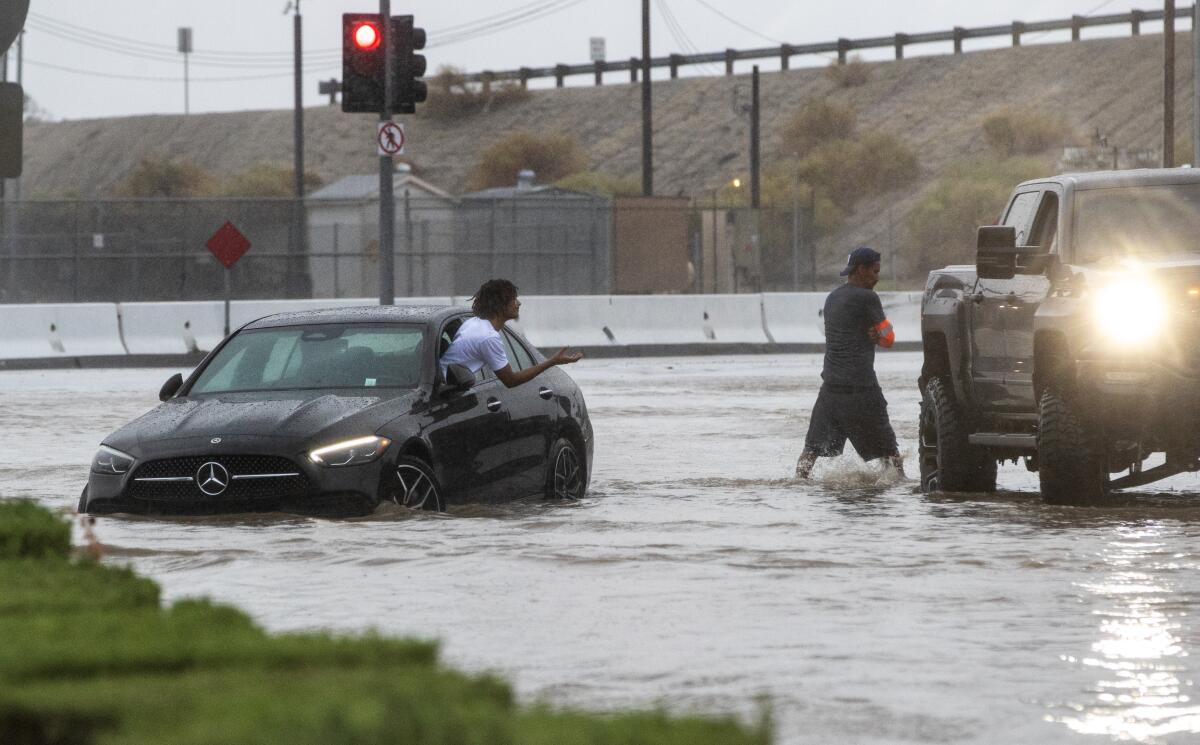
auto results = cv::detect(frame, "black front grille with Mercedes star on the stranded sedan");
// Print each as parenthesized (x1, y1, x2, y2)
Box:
(125, 455, 310, 501)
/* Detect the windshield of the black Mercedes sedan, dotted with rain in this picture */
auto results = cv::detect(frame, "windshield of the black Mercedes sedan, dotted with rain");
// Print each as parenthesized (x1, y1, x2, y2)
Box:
(190, 324, 422, 393)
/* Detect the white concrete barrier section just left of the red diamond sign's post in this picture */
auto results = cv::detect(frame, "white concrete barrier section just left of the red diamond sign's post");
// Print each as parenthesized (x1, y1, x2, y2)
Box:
(118, 301, 224, 354)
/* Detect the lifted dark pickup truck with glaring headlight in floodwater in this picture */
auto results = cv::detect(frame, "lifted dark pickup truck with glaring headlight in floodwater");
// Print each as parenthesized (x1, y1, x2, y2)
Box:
(918, 168, 1200, 504)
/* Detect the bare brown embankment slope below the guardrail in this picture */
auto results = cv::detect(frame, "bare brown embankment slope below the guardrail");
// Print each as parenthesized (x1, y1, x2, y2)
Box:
(25, 34, 1192, 281)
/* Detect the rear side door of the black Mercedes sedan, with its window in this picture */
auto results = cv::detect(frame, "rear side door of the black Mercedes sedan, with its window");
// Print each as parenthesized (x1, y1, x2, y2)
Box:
(502, 328, 554, 494)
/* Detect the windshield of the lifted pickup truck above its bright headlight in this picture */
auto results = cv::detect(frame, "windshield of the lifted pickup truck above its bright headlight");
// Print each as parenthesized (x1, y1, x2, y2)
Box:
(1075, 184, 1200, 264)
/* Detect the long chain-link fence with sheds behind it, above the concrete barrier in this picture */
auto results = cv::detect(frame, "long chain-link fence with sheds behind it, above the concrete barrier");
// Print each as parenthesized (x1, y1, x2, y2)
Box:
(0, 192, 883, 302)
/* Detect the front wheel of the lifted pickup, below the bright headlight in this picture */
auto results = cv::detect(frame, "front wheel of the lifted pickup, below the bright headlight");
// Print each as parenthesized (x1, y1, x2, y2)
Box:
(1038, 385, 1108, 504)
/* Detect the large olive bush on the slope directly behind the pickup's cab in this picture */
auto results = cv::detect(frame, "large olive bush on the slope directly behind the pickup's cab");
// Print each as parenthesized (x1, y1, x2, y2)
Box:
(906, 157, 1050, 274)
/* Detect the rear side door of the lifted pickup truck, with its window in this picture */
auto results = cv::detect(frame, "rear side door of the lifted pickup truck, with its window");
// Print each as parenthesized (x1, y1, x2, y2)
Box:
(970, 188, 1040, 409)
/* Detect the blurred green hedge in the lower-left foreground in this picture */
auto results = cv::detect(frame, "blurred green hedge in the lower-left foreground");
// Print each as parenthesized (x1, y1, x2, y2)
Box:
(0, 503, 770, 745)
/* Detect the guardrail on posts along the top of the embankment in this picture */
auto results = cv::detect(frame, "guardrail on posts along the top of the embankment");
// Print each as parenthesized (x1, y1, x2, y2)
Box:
(464, 6, 1194, 88)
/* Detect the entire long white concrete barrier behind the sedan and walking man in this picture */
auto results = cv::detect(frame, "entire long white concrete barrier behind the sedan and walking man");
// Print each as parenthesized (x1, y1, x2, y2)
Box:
(0, 293, 920, 370)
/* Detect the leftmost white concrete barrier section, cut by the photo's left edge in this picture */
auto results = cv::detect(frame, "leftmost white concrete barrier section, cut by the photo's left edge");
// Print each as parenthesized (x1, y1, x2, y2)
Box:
(0, 302, 126, 360)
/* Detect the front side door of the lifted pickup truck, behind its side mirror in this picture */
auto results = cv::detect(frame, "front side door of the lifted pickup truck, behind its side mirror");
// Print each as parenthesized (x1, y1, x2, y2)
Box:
(1004, 186, 1061, 411)
